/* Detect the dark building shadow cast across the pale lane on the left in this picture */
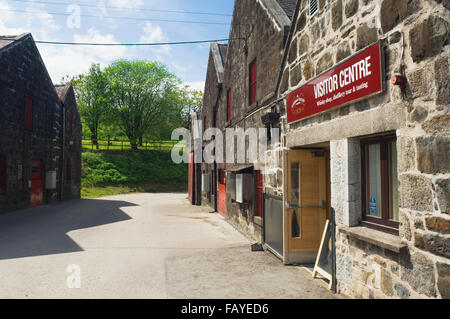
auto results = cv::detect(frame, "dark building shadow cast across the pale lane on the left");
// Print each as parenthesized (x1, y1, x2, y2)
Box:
(0, 199, 136, 260)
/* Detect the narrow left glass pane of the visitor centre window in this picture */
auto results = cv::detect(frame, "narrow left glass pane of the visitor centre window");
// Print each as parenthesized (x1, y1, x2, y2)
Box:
(367, 144, 382, 218)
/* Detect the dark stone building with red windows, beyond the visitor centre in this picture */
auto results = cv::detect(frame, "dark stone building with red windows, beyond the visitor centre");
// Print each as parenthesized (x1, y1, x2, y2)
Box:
(202, 0, 296, 242)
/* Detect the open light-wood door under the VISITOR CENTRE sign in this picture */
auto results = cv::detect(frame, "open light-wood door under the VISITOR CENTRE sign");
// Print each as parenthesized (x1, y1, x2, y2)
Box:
(284, 150, 327, 263)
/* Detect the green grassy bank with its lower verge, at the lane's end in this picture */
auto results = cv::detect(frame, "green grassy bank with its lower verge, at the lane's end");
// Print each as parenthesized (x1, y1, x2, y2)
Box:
(81, 151, 187, 198)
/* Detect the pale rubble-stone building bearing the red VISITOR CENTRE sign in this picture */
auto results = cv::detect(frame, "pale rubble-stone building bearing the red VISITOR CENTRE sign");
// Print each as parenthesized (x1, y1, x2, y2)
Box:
(272, 0, 450, 298)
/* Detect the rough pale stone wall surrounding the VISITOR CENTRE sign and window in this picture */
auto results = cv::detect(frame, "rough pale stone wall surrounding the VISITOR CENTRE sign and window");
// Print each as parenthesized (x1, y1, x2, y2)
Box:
(279, 0, 450, 298)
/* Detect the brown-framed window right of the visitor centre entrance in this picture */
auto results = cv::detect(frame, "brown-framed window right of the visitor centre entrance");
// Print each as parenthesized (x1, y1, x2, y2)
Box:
(361, 135, 399, 234)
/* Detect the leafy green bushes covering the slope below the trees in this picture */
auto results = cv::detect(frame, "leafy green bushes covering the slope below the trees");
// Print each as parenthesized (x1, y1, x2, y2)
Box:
(82, 151, 187, 188)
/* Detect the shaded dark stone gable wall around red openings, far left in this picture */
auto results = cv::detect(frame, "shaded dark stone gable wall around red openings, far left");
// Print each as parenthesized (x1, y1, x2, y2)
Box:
(0, 35, 81, 213)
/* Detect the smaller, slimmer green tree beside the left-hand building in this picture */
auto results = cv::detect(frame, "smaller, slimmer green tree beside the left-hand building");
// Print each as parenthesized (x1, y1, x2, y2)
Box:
(72, 64, 110, 149)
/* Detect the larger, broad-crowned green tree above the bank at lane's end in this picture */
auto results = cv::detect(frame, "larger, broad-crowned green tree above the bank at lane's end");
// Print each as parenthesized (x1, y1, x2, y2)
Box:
(105, 60, 182, 150)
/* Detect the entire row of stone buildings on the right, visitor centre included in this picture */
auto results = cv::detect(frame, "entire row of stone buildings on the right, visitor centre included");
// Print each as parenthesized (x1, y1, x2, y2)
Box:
(194, 0, 450, 298)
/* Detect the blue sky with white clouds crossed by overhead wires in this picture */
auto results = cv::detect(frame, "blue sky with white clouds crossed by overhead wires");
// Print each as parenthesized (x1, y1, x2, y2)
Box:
(0, 0, 234, 90)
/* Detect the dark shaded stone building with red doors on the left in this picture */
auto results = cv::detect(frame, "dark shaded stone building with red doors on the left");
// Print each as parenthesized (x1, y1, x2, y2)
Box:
(0, 34, 81, 212)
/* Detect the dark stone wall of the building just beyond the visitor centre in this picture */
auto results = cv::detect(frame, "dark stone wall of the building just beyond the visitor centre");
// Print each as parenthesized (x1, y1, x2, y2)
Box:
(218, 0, 289, 242)
